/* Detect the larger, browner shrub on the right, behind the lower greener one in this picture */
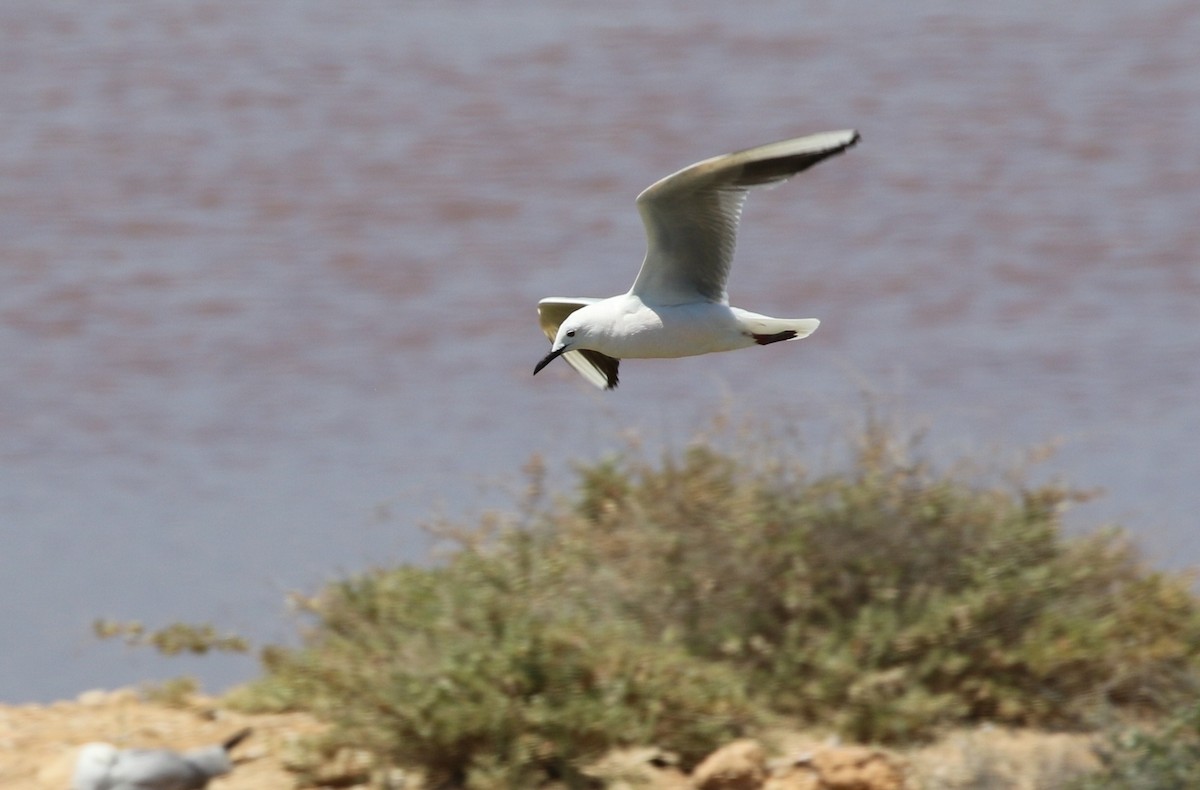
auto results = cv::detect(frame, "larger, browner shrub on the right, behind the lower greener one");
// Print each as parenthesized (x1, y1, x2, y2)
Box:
(546, 417, 1200, 741)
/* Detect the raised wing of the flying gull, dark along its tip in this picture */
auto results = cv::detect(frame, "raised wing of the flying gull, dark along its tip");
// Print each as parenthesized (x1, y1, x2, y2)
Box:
(630, 130, 858, 305)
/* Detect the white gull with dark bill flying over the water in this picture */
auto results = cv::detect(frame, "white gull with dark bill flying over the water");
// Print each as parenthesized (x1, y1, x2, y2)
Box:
(533, 130, 858, 389)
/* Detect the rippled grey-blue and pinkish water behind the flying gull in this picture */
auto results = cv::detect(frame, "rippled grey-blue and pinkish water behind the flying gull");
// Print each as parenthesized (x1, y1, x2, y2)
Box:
(0, 0, 1200, 701)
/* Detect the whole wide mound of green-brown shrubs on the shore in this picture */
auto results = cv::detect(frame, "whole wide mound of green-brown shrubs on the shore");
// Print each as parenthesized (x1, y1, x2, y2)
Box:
(236, 415, 1200, 788)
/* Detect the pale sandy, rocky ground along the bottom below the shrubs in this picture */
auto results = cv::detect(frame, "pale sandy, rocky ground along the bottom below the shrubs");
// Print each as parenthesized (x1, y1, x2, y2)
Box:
(0, 689, 1097, 790)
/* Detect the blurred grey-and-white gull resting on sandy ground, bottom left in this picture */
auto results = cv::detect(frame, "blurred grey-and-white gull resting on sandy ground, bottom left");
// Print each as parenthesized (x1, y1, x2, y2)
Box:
(71, 729, 250, 790)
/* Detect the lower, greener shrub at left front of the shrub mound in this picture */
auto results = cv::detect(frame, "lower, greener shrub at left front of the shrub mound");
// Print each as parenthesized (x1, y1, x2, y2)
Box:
(250, 534, 755, 788)
